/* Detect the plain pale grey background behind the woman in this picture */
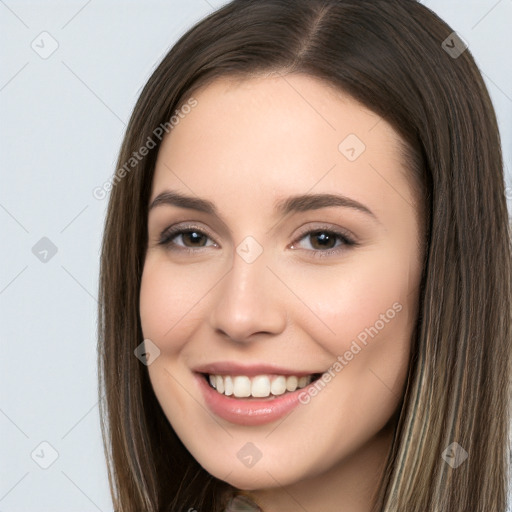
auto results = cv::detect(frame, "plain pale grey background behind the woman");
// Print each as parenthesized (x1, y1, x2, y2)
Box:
(0, 0, 512, 512)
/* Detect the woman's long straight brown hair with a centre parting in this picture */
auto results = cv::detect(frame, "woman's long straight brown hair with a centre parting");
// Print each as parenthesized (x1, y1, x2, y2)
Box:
(98, 0, 512, 512)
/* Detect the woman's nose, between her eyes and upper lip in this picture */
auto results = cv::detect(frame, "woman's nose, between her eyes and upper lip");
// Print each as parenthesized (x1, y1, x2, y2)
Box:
(210, 244, 287, 343)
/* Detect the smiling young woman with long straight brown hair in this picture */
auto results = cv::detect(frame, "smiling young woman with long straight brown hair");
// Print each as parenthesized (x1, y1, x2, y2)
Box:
(99, 0, 512, 512)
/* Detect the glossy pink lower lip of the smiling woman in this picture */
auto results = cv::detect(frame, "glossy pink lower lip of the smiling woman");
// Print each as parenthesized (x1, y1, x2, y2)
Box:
(196, 374, 313, 425)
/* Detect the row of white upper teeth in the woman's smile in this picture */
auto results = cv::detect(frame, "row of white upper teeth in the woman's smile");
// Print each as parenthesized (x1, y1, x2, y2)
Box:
(208, 375, 313, 398)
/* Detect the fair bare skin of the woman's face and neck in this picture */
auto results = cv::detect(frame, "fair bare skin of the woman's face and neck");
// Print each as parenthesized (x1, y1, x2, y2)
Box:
(140, 74, 423, 512)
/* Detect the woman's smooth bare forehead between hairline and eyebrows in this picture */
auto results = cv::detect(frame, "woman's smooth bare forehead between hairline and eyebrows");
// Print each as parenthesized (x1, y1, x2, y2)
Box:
(152, 75, 410, 222)
